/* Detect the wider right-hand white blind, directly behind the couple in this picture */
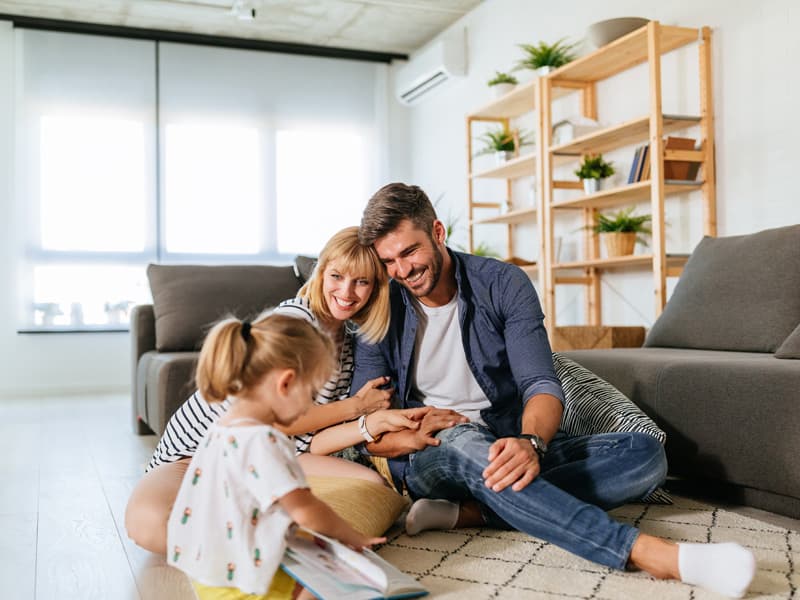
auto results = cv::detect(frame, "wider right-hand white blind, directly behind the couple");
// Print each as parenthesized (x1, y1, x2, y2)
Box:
(159, 43, 385, 261)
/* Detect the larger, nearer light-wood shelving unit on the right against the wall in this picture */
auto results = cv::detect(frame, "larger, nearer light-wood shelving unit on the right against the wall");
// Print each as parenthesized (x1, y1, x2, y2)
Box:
(538, 21, 717, 334)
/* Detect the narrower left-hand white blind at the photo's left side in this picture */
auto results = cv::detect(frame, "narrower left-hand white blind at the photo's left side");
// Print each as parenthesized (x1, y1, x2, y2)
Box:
(15, 29, 157, 329)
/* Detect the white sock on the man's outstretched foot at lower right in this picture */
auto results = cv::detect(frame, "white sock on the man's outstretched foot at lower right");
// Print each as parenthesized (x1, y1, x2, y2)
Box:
(678, 542, 756, 598)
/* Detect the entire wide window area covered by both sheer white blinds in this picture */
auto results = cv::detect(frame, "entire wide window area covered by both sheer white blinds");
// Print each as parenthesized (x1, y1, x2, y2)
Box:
(15, 29, 387, 330)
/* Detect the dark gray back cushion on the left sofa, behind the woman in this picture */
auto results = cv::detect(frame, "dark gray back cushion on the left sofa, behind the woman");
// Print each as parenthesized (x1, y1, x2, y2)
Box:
(147, 264, 300, 352)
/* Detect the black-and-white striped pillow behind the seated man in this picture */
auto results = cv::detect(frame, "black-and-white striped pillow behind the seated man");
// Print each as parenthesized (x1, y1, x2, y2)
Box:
(553, 352, 672, 504)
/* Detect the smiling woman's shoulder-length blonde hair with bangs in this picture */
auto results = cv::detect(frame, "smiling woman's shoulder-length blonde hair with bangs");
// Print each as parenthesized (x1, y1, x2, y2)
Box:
(298, 227, 389, 344)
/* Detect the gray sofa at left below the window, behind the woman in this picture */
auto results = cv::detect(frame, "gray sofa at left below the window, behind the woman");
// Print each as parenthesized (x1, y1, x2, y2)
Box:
(131, 257, 313, 435)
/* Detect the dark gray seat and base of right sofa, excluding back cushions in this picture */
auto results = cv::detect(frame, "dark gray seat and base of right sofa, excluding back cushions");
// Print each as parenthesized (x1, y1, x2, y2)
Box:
(567, 348, 800, 506)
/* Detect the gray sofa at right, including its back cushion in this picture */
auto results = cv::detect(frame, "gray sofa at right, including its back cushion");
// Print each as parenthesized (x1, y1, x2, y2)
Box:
(563, 225, 800, 518)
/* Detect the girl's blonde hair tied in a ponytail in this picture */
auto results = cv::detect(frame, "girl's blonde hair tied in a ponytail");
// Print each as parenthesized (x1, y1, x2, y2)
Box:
(200, 313, 336, 402)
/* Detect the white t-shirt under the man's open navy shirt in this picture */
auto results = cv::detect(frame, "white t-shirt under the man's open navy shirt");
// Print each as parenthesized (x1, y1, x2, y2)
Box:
(413, 294, 491, 425)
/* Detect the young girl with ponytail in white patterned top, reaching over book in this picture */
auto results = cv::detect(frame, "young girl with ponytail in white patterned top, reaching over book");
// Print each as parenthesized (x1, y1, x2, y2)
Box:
(167, 314, 394, 599)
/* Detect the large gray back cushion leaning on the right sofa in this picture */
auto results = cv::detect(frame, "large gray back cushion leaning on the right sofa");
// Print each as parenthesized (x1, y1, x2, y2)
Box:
(645, 225, 800, 352)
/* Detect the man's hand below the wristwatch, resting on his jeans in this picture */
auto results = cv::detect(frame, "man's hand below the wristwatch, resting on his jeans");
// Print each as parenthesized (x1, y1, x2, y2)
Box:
(483, 438, 539, 492)
